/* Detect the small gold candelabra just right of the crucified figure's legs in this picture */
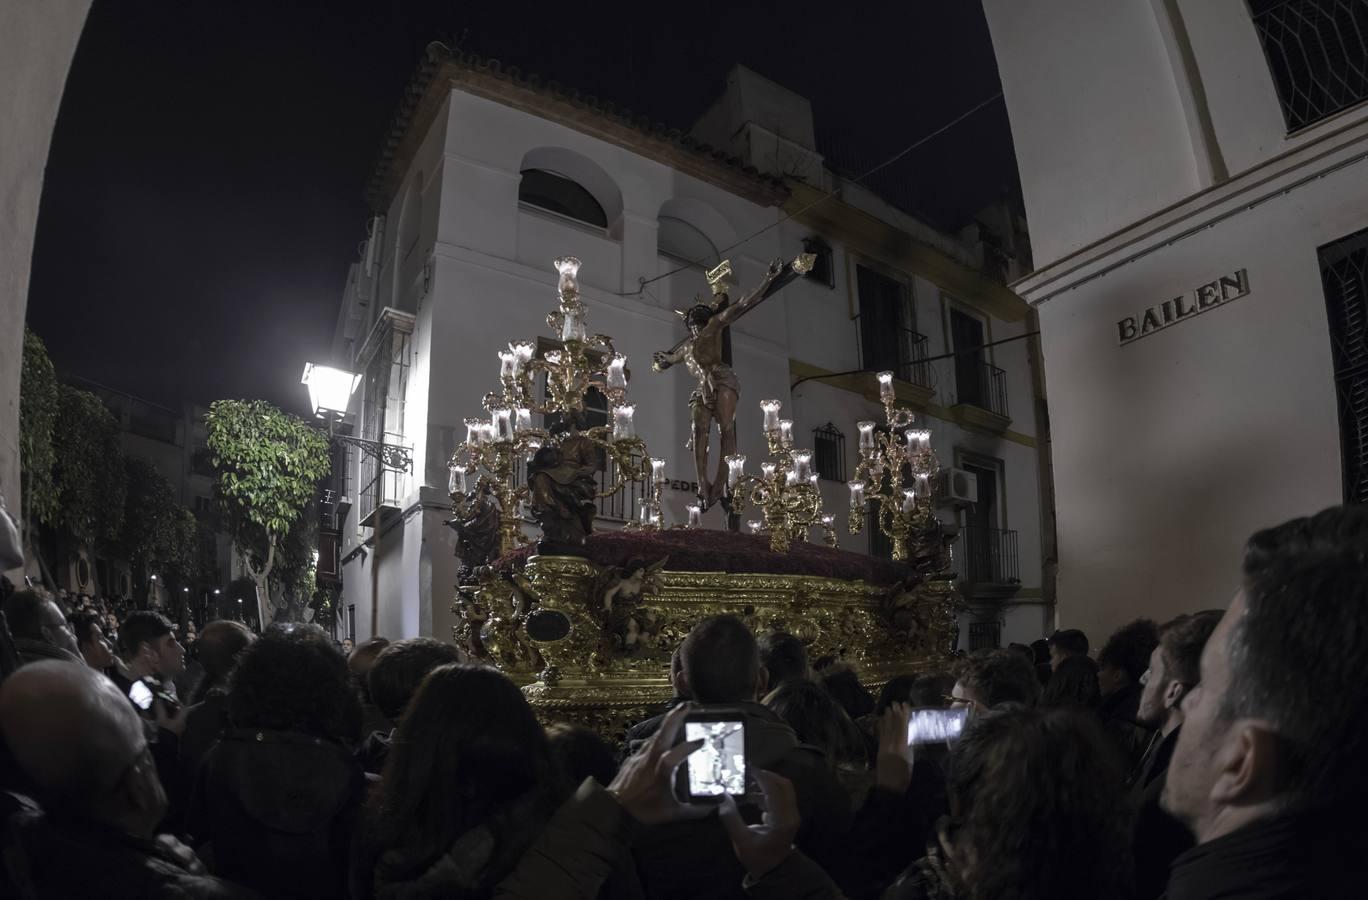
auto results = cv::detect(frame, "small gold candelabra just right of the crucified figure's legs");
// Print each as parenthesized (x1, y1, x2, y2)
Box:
(722, 399, 836, 553)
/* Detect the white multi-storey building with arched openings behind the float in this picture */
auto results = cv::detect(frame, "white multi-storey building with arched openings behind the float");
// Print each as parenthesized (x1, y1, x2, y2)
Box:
(325, 57, 1052, 646)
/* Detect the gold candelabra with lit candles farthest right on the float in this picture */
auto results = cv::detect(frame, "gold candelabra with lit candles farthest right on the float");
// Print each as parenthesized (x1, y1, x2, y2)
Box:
(848, 372, 940, 561)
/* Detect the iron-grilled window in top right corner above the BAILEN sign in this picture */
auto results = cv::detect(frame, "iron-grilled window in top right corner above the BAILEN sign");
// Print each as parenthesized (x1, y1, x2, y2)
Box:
(1249, 0, 1368, 131)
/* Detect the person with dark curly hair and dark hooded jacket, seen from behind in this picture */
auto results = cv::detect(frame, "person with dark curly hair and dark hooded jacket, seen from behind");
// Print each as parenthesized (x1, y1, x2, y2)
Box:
(186, 625, 363, 897)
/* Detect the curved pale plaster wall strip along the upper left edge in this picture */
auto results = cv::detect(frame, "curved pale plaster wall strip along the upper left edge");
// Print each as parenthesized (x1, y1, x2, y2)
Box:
(0, 0, 90, 574)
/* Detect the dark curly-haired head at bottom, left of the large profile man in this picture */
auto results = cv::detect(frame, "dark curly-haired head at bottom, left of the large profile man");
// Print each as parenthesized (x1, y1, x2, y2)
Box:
(884, 707, 1133, 900)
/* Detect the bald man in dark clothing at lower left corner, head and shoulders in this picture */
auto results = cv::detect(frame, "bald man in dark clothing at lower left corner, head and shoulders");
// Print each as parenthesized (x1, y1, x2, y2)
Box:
(0, 661, 250, 899)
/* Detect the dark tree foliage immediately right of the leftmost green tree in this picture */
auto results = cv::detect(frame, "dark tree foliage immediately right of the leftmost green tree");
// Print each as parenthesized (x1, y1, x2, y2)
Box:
(52, 384, 127, 544)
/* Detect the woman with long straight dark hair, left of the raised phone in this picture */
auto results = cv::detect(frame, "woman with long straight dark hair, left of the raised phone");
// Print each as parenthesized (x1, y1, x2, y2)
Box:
(352, 663, 565, 900)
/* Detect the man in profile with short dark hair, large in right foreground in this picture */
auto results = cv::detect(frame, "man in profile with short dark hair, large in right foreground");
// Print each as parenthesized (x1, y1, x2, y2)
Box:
(1161, 506, 1368, 900)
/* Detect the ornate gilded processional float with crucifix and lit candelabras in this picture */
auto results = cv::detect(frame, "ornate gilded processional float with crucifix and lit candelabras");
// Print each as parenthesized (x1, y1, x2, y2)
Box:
(449, 254, 958, 737)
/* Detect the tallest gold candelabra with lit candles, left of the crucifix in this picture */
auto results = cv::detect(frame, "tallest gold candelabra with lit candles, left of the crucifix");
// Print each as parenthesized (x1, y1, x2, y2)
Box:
(449, 256, 665, 554)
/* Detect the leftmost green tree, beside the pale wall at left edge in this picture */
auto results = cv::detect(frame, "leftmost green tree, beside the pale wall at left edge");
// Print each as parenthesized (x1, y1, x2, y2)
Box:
(19, 330, 57, 543)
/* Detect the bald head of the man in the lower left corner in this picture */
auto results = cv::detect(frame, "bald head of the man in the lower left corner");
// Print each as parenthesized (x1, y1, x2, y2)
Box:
(0, 661, 146, 811)
